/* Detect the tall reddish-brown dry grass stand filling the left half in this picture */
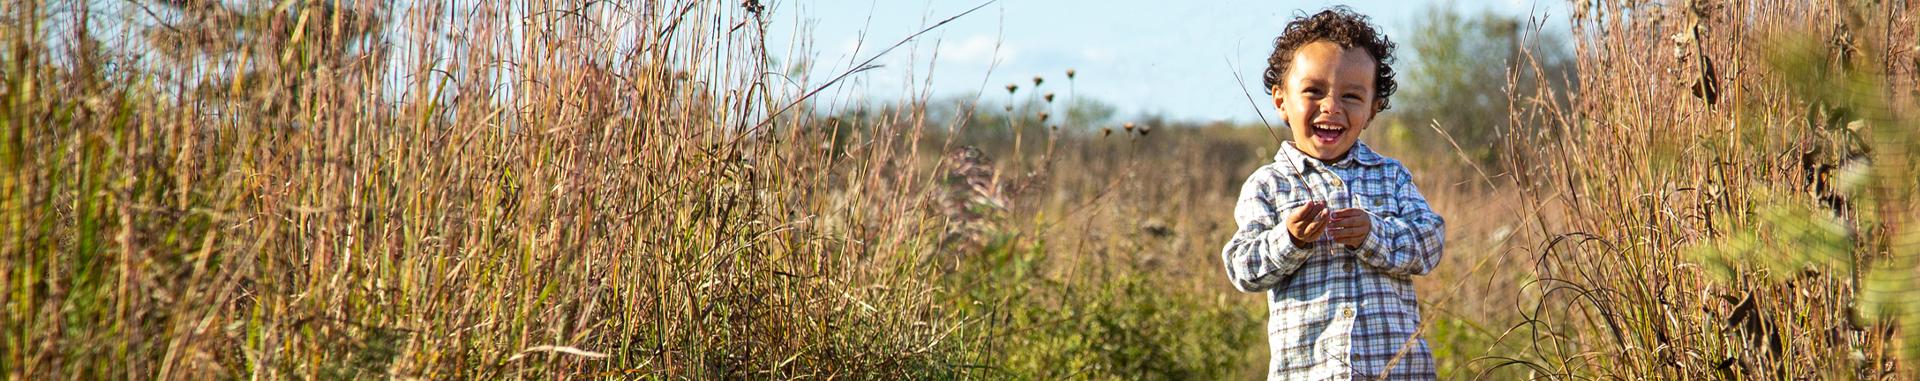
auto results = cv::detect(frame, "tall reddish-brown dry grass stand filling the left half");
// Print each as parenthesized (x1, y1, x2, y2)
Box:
(0, 0, 973, 379)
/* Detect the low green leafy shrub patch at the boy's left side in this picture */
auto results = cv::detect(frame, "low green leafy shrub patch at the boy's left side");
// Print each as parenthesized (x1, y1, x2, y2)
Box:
(947, 239, 1265, 379)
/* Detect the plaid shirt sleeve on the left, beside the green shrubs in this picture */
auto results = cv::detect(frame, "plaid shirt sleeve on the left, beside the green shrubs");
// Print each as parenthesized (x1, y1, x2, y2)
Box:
(1221, 167, 1309, 292)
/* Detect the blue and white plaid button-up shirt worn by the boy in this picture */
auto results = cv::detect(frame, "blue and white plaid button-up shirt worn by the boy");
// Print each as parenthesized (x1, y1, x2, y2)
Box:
(1221, 142, 1444, 379)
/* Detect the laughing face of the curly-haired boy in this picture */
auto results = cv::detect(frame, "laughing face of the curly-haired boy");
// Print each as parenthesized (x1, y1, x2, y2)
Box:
(1273, 40, 1375, 162)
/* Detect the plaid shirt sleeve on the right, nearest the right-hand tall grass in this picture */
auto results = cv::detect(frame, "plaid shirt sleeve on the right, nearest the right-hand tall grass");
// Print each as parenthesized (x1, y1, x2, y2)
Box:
(1356, 164, 1446, 277)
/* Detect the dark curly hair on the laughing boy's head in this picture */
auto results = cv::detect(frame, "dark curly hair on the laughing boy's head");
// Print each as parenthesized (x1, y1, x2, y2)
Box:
(1265, 6, 1400, 112)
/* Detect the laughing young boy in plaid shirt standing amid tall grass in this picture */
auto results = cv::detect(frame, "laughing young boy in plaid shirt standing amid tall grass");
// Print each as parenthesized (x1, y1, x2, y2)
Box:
(1221, 8, 1444, 379)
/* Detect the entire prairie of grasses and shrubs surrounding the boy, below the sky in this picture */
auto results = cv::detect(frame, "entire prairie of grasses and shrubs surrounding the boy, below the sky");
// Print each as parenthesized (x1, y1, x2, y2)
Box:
(0, 0, 1920, 379)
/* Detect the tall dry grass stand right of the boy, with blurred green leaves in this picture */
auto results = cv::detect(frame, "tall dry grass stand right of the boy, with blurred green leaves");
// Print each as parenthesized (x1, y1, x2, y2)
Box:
(1484, 0, 1920, 379)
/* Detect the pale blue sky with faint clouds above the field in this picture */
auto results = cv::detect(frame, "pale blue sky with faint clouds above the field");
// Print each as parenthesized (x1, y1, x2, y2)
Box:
(768, 0, 1565, 121)
